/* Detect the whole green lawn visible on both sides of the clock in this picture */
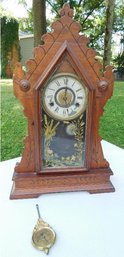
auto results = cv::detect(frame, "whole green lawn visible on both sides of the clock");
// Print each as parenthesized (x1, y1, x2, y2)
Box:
(1, 80, 124, 160)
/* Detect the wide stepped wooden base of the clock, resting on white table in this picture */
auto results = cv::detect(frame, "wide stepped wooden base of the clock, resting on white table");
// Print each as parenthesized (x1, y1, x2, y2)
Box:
(10, 168, 115, 199)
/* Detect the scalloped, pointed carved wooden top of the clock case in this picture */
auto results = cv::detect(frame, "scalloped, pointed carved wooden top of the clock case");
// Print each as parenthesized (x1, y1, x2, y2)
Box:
(14, 3, 113, 92)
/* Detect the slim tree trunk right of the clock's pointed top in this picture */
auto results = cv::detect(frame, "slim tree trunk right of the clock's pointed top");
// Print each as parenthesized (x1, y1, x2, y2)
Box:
(103, 0, 115, 69)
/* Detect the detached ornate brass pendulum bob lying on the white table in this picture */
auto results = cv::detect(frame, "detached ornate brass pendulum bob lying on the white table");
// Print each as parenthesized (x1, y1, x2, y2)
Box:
(32, 204, 56, 254)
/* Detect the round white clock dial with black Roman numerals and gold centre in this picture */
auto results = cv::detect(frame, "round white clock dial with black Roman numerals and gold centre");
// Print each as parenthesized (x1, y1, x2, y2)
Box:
(43, 73, 87, 120)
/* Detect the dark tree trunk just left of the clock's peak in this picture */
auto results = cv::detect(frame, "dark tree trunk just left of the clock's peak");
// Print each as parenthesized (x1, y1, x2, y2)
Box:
(33, 0, 46, 47)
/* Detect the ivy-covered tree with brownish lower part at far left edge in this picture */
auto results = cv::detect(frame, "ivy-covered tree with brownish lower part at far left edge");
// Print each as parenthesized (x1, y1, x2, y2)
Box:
(0, 8, 20, 78)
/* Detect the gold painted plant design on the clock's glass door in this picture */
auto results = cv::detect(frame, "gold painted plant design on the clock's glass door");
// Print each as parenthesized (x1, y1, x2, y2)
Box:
(43, 115, 85, 167)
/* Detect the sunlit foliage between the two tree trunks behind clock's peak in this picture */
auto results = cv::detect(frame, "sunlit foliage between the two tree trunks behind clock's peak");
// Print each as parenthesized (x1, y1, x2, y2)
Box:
(47, 0, 106, 51)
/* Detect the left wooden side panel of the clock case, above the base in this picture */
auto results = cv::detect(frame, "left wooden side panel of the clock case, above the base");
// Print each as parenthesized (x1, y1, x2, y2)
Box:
(14, 80, 35, 173)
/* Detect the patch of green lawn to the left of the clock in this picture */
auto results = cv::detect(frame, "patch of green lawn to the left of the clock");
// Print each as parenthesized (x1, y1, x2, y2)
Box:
(1, 80, 27, 160)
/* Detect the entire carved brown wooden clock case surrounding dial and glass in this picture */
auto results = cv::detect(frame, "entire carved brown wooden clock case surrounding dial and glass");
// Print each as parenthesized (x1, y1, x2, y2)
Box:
(10, 4, 115, 199)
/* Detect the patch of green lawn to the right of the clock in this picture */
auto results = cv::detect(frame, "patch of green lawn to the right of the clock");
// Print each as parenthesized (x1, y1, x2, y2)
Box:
(99, 81, 124, 148)
